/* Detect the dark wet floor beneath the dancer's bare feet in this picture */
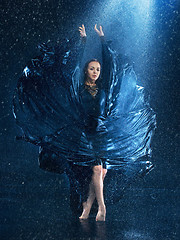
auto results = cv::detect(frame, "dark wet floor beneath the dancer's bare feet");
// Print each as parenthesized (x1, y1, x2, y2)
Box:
(1, 184, 180, 240)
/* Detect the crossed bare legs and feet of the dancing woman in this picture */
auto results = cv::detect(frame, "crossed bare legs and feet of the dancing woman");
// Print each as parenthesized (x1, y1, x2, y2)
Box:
(79, 165, 107, 221)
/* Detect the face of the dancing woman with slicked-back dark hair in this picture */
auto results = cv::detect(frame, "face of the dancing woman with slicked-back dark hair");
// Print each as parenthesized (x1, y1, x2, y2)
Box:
(87, 61, 101, 83)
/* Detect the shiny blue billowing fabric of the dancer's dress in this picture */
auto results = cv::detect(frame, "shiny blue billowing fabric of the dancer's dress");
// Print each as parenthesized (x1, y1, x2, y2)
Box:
(13, 35, 156, 210)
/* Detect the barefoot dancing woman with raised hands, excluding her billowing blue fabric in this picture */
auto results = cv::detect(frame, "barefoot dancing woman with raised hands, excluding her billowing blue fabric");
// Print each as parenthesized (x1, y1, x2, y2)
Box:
(79, 25, 107, 221)
